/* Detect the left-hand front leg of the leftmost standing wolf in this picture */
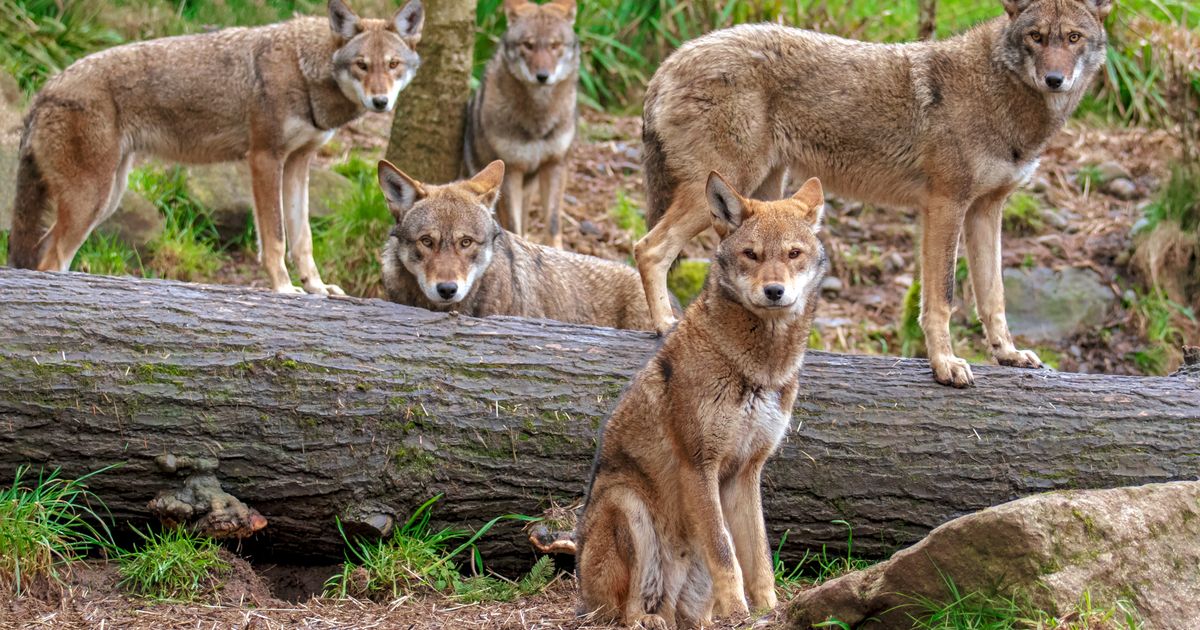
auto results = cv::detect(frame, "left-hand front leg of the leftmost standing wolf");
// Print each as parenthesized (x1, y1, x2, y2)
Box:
(250, 149, 304, 293)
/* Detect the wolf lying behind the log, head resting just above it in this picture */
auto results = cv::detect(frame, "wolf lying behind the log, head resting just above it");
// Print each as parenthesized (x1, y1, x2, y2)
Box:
(379, 161, 650, 330)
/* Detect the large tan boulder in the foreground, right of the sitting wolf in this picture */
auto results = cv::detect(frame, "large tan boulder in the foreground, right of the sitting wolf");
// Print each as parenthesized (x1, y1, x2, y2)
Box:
(786, 481, 1200, 630)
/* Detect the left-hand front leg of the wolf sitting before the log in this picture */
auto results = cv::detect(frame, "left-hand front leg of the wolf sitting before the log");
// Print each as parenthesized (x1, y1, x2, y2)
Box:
(679, 464, 750, 617)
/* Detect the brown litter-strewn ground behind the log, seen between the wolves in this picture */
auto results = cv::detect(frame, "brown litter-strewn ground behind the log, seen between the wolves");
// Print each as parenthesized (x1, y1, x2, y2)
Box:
(307, 112, 1180, 374)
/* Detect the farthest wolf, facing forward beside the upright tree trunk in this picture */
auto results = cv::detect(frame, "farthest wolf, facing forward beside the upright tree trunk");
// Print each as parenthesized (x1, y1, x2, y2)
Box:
(463, 0, 580, 248)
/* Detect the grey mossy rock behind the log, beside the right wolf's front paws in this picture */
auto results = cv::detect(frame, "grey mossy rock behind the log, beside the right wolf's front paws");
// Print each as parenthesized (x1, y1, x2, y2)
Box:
(1003, 268, 1116, 342)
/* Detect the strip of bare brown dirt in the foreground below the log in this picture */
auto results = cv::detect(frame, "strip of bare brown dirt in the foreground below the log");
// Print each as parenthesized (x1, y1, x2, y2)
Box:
(0, 556, 781, 630)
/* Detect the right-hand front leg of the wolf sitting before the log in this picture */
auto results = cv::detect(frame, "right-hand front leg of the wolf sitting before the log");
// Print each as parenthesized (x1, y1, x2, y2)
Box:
(721, 460, 779, 610)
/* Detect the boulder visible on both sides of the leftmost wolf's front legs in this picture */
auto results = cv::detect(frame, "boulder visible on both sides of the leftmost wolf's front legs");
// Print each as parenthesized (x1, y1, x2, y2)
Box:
(187, 162, 354, 241)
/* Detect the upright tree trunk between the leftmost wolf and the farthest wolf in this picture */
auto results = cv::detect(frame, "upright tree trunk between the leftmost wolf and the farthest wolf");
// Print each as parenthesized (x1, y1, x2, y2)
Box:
(388, 0, 475, 184)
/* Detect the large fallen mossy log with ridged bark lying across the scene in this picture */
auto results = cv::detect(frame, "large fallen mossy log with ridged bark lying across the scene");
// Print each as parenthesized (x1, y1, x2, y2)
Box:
(0, 270, 1200, 569)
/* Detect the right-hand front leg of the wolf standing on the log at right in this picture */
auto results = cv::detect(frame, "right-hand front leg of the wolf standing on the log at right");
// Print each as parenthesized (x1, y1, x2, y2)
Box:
(965, 191, 1042, 367)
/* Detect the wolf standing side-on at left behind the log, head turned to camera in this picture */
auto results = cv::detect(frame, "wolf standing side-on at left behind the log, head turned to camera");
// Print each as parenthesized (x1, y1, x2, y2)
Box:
(8, 0, 425, 294)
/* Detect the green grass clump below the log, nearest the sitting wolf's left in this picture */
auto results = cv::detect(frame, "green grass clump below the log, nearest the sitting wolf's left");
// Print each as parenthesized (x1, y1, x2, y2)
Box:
(325, 494, 548, 601)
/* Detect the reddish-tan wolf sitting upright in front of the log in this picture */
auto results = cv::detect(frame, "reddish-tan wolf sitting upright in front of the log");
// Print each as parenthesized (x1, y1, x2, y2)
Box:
(576, 173, 827, 628)
